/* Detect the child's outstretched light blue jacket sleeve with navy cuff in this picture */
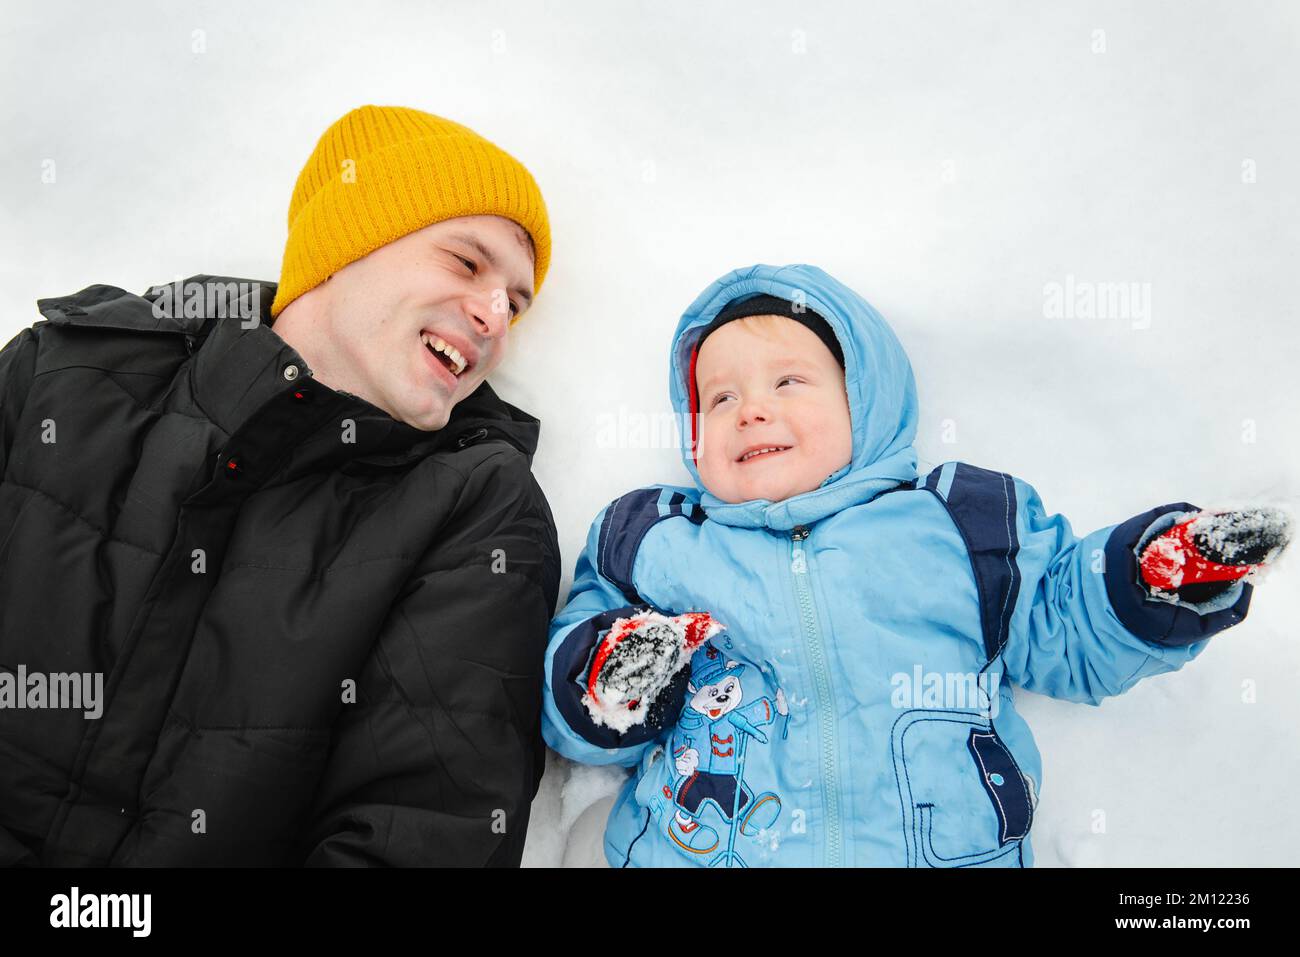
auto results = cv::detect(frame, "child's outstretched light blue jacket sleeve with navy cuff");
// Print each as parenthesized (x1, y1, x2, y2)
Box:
(1002, 479, 1251, 705)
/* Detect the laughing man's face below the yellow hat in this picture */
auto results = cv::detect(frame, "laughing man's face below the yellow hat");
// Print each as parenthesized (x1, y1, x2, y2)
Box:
(274, 216, 533, 432)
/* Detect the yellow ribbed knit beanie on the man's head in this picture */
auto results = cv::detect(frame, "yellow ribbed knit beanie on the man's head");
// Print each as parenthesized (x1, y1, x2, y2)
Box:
(270, 107, 551, 319)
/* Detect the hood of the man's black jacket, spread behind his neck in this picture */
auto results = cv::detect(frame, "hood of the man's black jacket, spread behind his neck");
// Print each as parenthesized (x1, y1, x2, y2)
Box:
(36, 274, 541, 464)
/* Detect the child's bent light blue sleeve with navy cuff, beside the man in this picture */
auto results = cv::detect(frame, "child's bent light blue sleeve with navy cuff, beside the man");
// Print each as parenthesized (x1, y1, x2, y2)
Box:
(542, 502, 689, 767)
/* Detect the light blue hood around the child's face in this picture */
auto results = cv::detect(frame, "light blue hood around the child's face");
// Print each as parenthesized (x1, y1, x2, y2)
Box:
(668, 264, 918, 531)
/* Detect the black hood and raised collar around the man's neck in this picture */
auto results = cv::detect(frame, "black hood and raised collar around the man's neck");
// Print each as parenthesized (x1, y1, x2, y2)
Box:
(36, 274, 541, 465)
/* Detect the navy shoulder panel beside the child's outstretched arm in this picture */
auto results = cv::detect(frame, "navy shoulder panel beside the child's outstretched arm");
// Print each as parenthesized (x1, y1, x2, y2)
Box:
(924, 462, 1021, 661)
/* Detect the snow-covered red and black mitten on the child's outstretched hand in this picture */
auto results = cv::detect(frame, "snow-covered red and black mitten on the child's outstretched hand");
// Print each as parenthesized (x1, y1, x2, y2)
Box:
(1140, 507, 1291, 602)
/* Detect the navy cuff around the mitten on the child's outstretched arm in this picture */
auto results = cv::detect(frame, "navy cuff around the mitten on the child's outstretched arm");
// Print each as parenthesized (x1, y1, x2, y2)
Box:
(1105, 502, 1255, 648)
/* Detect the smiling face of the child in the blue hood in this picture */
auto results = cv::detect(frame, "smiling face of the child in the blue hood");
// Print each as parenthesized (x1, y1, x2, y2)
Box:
(696, 316, 853, 502)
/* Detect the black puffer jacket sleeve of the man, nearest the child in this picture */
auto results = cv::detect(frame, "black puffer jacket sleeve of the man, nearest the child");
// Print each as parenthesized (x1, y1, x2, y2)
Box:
(304, 450, 559, 866)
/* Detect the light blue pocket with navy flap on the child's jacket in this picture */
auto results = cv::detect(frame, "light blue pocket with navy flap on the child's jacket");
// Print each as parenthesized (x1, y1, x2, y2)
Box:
(891, 709, 1034, 867)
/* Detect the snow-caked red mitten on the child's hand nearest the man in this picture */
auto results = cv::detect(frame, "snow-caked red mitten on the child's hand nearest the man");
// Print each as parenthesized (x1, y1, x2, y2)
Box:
(582, 611, 724, 732)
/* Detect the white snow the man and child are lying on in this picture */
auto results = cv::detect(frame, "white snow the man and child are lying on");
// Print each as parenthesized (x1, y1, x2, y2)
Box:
(0, 0, 1300, 867)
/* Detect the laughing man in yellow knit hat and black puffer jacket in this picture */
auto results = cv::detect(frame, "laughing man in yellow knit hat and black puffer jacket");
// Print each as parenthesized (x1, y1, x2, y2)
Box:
(0, 107, 559, 866)
